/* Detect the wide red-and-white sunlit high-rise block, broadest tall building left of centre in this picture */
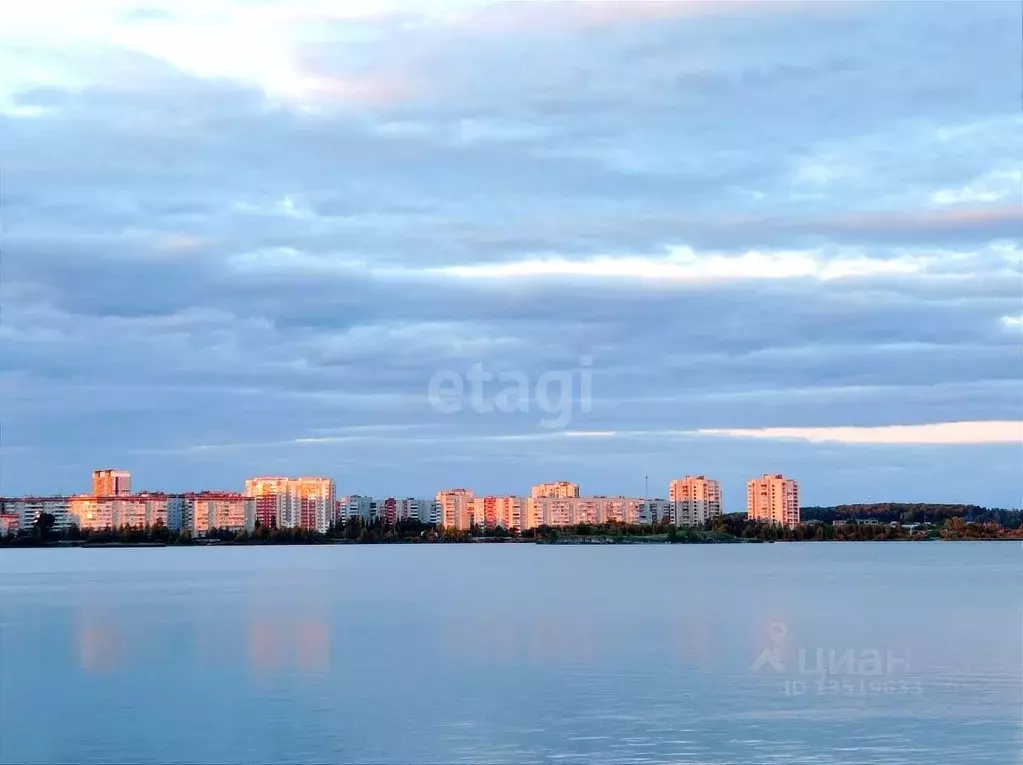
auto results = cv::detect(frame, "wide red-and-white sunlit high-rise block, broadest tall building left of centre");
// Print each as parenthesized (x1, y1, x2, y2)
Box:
(246, 478, 336, 533)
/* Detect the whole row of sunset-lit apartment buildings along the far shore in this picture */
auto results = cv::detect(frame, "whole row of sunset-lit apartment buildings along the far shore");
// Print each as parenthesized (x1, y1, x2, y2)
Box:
(0, 470, 799, 536)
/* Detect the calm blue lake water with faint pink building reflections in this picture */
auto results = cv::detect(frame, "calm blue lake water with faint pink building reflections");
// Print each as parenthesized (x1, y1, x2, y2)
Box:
(0, 542, 1023, 765)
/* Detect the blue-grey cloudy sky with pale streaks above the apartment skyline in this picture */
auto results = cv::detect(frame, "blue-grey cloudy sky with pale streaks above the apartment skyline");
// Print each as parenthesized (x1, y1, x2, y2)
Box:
(0, 0, 1023, 510)
